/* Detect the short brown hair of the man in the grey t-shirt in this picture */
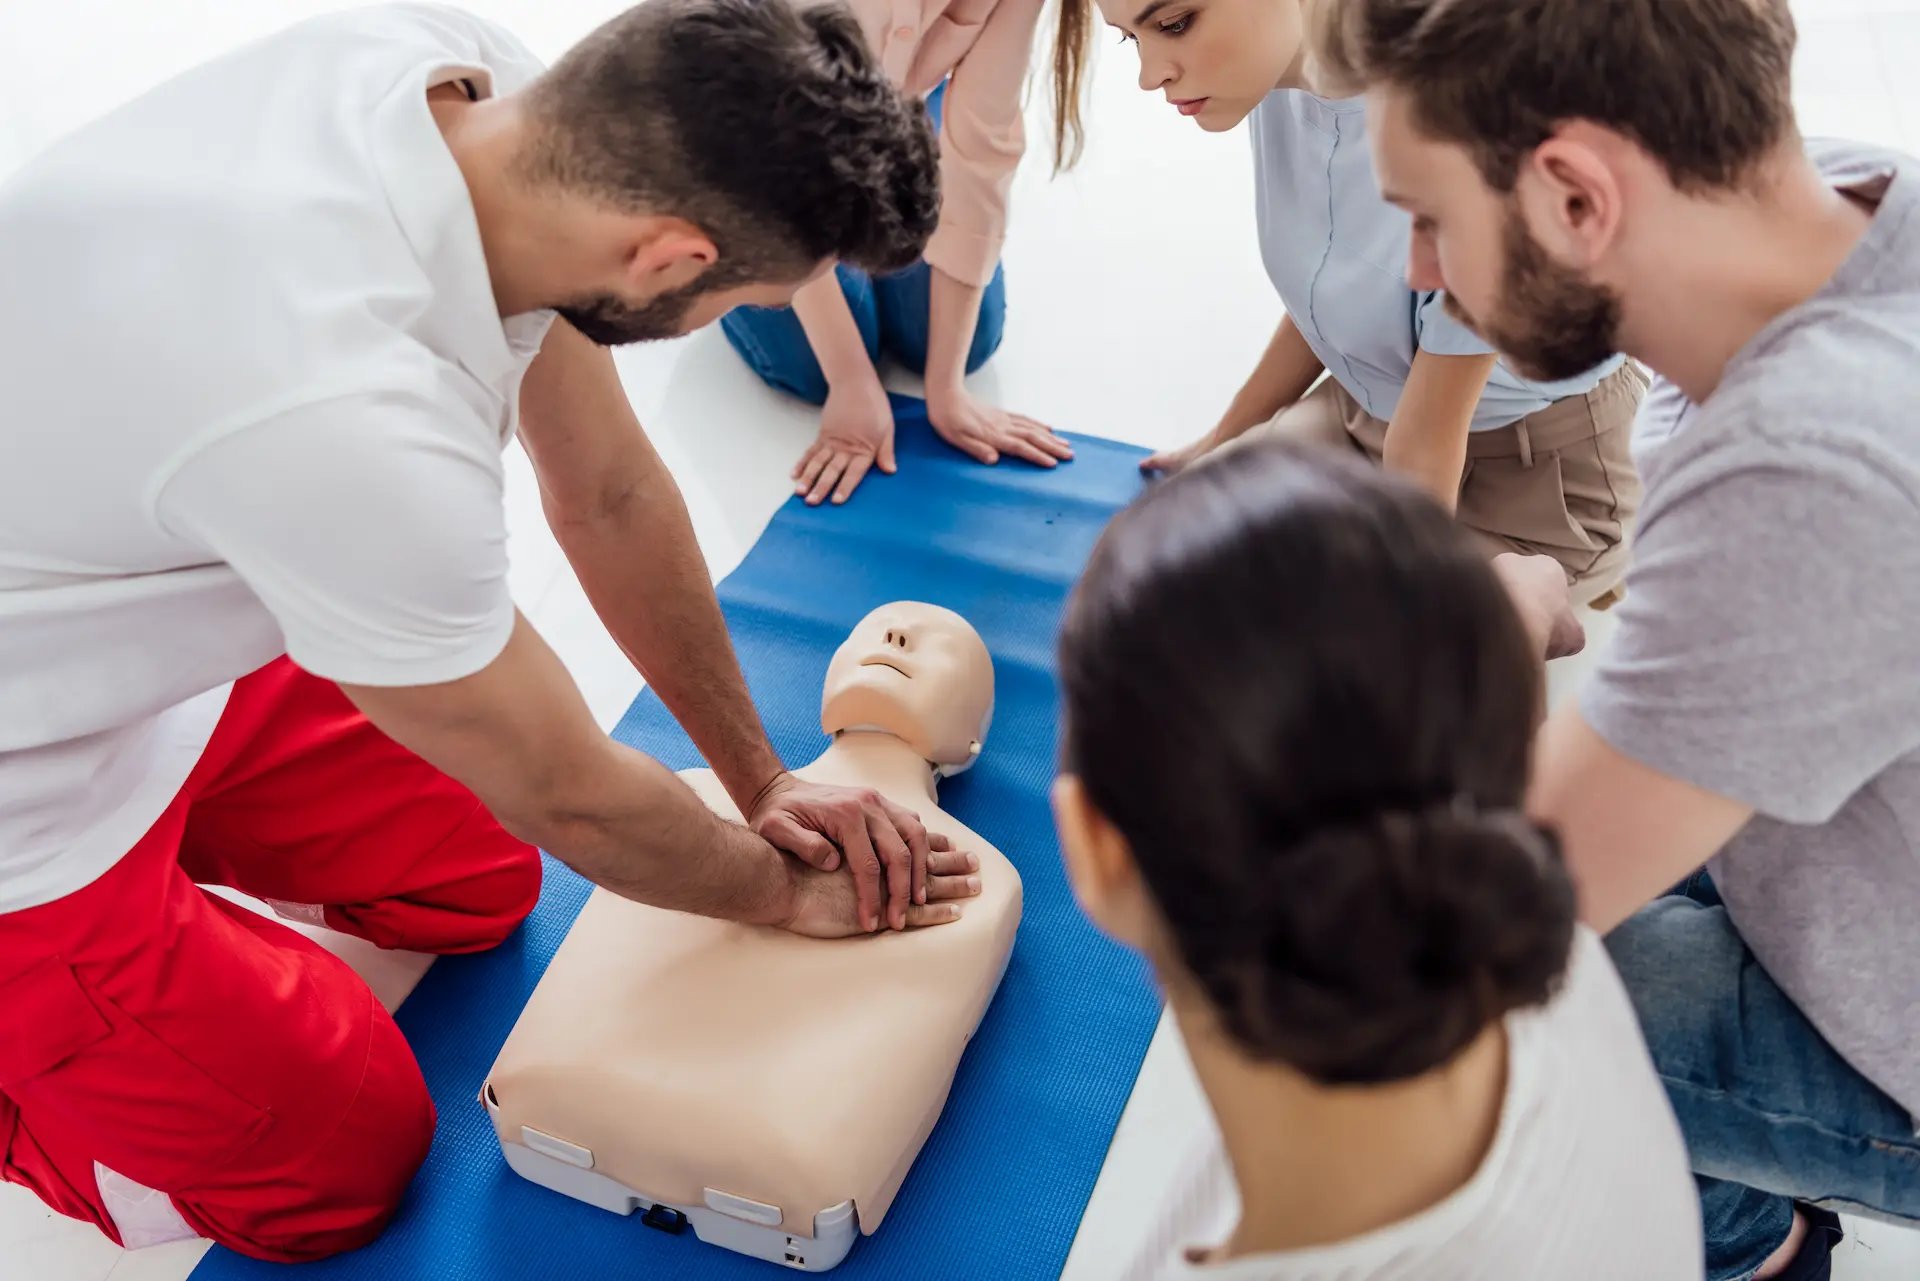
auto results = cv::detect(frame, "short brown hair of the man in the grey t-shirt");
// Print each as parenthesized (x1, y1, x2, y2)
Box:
(1308, 0, 1797, 192)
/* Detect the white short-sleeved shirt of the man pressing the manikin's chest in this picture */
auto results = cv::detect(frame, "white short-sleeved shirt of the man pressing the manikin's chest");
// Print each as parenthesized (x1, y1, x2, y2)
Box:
(0, 6, 551, 912)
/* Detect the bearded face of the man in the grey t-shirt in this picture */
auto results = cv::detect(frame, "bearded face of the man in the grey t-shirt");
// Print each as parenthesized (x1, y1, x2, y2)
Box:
(1367, 88, 1620, 380)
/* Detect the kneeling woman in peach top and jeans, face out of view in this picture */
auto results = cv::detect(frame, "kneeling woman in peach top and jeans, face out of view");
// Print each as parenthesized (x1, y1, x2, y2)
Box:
(720, 0, 1083, 503)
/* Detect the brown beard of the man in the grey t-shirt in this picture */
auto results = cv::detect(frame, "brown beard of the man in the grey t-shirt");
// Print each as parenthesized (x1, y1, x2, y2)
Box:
(1444, 205, 1620, 382)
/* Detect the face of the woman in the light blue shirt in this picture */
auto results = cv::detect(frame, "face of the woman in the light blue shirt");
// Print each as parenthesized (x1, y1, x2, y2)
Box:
(1098, 0, 1304, 133)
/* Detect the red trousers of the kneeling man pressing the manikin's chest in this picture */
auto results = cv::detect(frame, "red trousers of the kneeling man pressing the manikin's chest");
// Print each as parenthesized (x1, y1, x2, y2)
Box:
(0, 659, 540, 1260)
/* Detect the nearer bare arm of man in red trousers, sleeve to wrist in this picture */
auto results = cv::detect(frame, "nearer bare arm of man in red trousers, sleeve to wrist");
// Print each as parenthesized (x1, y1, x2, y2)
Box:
(342, 618, 799, 924)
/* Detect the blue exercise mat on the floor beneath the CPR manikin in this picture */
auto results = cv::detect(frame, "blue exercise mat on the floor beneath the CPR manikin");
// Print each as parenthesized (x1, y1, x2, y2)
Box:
(194, 399, 1160, 1281)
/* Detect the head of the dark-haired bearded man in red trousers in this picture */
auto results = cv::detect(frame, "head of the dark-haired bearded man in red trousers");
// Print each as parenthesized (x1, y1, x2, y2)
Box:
(484, 0, 939, 346)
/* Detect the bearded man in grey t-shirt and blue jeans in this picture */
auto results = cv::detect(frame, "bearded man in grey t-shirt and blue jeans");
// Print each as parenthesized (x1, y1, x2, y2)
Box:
(1319, 0, 1920, 1281)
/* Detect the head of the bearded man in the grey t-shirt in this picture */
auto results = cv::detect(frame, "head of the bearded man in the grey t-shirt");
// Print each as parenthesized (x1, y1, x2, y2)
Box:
(1308, 0, 1799, 378)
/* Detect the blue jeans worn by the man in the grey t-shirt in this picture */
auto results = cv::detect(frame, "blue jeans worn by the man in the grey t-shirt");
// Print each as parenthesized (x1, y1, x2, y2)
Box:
(1607, 872, 1920, 1281)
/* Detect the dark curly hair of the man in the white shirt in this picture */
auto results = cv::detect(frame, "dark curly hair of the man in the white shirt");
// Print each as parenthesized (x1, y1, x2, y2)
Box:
(528, 0, 939, 288)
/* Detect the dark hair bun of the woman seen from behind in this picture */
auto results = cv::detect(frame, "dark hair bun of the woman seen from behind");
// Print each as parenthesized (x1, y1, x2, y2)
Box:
(1187, 805, 1574, 1083)
